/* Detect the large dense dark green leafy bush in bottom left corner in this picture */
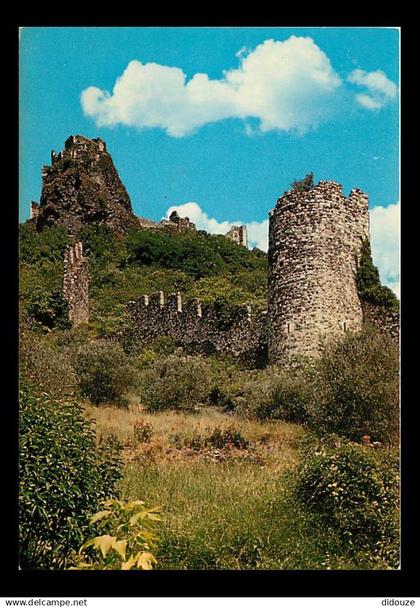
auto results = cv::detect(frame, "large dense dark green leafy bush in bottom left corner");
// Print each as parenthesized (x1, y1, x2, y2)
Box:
(19, 380, 121, 569)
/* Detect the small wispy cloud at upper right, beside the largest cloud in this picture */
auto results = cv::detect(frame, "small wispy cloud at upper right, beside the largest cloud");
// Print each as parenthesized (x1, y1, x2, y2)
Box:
(347, 69, 398, 110)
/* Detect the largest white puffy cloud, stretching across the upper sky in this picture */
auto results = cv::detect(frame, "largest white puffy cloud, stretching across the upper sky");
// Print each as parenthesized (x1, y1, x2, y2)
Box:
(81, 36, 341, 137)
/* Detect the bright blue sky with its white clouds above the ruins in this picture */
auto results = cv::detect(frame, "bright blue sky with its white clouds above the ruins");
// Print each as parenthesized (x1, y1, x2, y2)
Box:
(20, 27, 399, 292)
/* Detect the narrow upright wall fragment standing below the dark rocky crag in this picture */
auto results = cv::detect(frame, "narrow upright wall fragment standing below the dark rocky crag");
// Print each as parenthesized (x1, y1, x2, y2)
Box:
(63, 242, 89, 326)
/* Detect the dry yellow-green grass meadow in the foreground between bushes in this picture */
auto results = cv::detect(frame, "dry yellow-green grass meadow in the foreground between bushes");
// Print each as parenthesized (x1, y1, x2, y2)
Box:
(86, 400, 364, 569)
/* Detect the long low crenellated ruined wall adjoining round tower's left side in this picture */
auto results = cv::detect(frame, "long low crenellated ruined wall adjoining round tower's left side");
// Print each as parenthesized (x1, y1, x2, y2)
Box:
(127, 291, 267, 363)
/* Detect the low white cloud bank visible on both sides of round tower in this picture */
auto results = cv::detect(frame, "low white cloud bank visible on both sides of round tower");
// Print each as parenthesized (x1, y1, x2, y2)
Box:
(167, 202, 400, 297)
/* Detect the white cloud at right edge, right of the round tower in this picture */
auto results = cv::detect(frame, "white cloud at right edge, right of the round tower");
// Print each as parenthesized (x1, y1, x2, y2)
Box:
(370, 203, 400, 297)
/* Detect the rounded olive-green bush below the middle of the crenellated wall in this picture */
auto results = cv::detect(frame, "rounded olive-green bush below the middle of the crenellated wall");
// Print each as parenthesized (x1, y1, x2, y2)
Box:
(140, 354, 210, 411)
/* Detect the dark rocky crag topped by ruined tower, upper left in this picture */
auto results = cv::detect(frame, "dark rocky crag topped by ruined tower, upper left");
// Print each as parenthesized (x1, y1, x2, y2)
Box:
(31, 135, 138, 235)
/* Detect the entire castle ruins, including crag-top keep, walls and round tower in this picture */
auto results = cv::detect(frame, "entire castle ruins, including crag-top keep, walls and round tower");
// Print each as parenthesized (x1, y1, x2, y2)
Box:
(46, 135, 399, 364)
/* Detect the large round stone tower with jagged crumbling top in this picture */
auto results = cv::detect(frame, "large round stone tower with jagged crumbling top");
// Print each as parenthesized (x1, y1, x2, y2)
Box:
(268, 181, 369, 363)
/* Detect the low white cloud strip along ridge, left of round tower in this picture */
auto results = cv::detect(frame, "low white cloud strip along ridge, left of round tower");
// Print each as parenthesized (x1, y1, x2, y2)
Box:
(166, 202, 268, 251)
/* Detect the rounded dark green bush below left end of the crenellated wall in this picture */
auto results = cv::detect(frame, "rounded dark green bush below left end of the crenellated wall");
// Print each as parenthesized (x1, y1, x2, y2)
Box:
(75, 340, 135, 405)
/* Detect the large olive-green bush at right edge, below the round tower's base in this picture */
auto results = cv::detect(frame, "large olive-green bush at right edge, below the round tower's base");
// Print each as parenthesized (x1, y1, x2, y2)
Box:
(310, 328, 399, 443)
